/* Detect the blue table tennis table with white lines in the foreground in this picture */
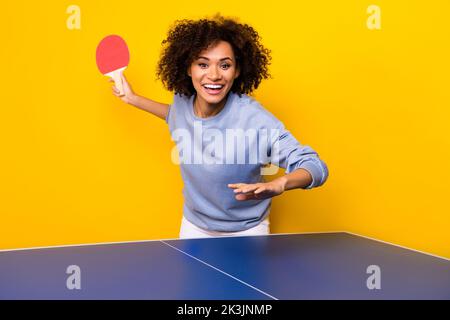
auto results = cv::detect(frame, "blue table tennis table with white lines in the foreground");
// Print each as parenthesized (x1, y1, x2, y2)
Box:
(0, 232, 450, 300)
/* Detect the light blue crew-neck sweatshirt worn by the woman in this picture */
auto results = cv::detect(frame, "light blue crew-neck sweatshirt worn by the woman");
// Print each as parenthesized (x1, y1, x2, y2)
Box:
(166, 91, 328, 232)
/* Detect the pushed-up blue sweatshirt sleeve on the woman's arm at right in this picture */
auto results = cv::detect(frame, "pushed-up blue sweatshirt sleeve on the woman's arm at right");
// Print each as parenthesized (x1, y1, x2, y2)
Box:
(271, 122, 328, 189)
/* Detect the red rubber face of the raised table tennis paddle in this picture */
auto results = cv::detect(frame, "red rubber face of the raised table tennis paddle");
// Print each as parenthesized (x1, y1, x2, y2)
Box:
(97, 35, 130, 74)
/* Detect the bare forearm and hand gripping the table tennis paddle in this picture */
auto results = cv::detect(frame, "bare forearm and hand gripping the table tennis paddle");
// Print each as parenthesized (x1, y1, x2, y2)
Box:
(111, 75, 169, 120)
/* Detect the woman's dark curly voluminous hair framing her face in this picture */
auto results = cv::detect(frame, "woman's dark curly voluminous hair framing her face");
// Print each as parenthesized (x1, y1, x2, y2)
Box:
(156, 13, 272, 97)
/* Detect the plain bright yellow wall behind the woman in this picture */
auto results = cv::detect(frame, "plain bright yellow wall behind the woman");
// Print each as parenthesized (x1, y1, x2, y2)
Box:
(0, 0, 450, 257)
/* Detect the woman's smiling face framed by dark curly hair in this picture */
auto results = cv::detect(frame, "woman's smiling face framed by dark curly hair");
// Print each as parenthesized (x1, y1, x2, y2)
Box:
(188, 41, 239, 106)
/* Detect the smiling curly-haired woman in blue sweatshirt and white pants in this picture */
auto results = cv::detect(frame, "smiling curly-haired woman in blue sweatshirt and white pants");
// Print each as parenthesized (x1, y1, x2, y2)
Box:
(113, 15, 328, 238)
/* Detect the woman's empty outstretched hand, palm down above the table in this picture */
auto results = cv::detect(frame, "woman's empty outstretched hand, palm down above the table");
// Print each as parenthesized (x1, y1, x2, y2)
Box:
(228, 179, 286, 201)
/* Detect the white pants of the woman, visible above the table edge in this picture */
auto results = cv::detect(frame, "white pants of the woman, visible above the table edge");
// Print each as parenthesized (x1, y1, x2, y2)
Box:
(180, 216, 270, 239)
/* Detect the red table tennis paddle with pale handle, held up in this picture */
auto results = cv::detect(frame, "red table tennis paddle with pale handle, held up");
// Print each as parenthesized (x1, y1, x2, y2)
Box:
(97, 35, 130, 96)
